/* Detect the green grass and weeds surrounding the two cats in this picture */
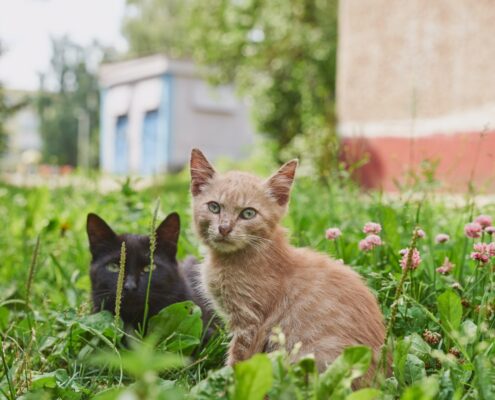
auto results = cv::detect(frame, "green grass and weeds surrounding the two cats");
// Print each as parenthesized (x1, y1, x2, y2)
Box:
(0, 175, 495, 399)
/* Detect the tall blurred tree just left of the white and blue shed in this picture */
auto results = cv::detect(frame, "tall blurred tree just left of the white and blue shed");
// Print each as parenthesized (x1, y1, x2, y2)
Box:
(37, 37, 102, 166)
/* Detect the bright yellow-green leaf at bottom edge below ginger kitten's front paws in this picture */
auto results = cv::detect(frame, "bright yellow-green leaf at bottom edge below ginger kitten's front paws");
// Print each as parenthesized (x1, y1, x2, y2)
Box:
(234, 354, 273, 400)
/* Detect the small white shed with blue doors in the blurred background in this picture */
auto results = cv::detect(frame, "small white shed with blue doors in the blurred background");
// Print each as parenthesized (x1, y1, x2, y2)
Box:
(100, 55, 254, 176)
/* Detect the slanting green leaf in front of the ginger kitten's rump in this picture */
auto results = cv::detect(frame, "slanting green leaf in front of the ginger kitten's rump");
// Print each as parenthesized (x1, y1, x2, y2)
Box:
(316, 346, 371, 400)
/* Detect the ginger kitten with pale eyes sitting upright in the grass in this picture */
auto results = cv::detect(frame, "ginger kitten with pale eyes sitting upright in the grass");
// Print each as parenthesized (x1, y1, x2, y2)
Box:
(191, 149, 385, 371)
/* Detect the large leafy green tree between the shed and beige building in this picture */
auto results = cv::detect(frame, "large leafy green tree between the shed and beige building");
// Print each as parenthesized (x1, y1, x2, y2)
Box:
(124, 0, 338, 177)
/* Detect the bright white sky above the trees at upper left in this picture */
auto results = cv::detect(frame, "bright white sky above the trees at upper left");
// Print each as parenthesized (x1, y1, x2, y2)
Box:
(0, 0, 126, 90)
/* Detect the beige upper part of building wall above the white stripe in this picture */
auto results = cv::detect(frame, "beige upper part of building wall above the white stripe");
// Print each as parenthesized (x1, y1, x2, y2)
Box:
(337, 0, 495, 133)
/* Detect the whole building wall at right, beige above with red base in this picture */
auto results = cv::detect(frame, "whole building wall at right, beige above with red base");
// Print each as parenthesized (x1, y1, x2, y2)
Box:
(337, 0, 495, 191)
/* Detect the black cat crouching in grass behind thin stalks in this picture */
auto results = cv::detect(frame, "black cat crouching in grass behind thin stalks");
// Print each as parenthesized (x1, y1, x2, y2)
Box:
(86, 213, 213, 333)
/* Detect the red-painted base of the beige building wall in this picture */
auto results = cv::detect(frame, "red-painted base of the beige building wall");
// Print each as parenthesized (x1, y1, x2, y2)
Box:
(342, 131, 495, 192)
